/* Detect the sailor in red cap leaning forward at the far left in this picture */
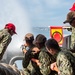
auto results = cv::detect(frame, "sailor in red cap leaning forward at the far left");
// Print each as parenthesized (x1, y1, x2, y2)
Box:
(0, 23, 17, 60)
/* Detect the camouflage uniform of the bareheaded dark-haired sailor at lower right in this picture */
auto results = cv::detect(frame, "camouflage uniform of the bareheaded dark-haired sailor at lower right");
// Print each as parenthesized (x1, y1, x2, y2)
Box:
(56, 51, 75, 75)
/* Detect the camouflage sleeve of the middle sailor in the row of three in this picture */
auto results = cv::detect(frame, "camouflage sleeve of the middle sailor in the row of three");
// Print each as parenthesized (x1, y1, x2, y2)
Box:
(39, 52, 51, 75)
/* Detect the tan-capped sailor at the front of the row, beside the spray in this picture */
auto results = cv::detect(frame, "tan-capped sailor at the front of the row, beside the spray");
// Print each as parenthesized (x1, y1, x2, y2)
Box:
(22, 33, 41, 75)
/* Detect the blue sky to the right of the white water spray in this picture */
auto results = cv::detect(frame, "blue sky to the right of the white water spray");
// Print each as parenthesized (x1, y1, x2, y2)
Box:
(17, 0, 75, 26)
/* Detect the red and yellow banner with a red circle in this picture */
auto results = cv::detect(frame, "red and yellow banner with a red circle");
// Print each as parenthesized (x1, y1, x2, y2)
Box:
(50, 26, 63, 45)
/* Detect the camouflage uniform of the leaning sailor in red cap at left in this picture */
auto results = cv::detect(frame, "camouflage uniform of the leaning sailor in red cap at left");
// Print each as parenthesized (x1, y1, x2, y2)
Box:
(0, 29, 12, 60)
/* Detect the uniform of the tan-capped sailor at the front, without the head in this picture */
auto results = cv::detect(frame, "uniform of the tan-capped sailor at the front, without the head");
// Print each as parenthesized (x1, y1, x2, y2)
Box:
(22, 45, 41, 75)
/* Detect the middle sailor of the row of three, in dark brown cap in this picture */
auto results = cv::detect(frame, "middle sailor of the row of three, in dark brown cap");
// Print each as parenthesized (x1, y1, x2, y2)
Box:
(34, 34, 56, 75)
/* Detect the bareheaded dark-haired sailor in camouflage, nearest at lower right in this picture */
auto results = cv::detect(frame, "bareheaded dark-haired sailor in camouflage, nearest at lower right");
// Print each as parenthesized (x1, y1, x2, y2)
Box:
(45, 39, 75, 75)
